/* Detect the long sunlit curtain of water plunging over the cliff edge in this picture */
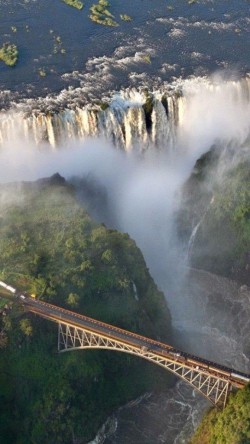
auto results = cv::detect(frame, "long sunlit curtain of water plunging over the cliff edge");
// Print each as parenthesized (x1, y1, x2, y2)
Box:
(0, 77, 250, 152)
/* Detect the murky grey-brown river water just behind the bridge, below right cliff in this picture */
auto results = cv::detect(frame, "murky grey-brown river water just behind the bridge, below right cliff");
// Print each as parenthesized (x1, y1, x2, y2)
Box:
(170, 269, 250, 372)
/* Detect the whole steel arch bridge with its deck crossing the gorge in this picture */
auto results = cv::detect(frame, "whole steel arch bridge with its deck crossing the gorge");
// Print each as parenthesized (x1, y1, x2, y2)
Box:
(0, 281, 250, 407)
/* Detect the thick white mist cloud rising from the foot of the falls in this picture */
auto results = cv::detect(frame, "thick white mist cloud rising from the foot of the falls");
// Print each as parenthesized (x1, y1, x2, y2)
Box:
(0, 79, 250, 304)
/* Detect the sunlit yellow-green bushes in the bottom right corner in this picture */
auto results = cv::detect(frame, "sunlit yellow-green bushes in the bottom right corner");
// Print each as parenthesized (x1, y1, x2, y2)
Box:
(190, 385, 250, 444)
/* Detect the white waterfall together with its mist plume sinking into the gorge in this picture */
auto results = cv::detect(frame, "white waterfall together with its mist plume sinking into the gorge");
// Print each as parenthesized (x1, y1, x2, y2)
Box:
(0, 77, 250, 288)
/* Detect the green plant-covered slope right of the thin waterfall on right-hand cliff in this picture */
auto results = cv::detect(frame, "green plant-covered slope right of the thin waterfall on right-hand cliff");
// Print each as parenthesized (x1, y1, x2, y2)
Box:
(190, 162, 250, 279)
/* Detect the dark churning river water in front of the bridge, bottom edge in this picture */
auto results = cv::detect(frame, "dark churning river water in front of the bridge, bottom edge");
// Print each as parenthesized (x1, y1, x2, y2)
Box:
(89, 382, 209, 444)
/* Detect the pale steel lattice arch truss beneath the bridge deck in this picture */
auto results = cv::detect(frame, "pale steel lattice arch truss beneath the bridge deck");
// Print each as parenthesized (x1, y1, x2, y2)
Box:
(58, 323, 232, 407)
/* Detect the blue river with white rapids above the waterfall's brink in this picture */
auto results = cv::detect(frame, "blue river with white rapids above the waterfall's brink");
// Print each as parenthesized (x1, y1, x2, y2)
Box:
(0, 0, 250, 106)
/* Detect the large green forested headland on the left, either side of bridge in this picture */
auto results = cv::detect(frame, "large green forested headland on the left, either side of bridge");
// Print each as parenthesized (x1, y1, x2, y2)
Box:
(0, 176, 170, 444)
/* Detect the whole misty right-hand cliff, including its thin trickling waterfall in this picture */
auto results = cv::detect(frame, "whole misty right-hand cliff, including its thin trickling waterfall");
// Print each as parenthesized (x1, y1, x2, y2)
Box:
(178, 150, 250, 285)
